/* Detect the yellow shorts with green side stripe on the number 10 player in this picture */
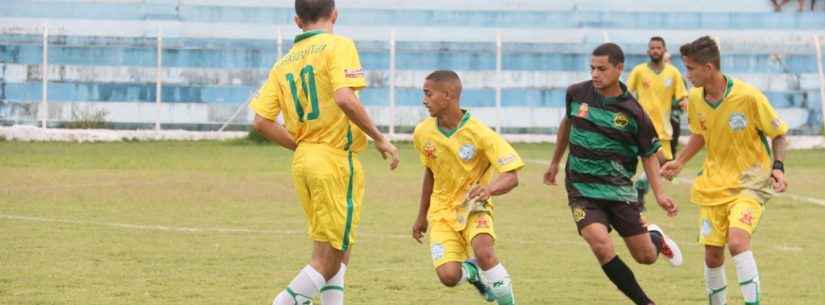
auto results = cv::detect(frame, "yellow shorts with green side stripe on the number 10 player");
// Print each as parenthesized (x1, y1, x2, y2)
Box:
(292, 143, 364, 251)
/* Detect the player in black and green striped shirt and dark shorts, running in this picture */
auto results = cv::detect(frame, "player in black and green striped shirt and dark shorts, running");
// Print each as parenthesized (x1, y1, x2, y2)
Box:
(544, 43, 682, 305)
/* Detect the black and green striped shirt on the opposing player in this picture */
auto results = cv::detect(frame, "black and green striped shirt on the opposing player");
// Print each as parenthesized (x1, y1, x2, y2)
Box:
(565, 81, 662, 202)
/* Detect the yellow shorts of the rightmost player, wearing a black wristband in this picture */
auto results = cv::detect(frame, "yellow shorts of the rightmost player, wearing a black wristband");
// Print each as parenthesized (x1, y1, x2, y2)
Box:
(699, 198, 765, 247)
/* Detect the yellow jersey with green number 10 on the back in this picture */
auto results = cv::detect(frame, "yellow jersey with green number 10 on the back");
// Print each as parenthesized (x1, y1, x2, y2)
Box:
(249, 31, 367, 152)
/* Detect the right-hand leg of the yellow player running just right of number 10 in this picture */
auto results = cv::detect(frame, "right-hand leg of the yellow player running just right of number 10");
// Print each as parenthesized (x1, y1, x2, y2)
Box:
(470, 213, 508, 305)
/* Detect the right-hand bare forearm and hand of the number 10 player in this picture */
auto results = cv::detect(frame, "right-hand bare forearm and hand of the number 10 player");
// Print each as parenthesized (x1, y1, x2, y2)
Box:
(335, 87, 399, 169)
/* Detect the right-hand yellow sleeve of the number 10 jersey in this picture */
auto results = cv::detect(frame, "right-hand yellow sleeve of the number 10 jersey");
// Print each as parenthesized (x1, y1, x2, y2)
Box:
(329, 38, 367, 91)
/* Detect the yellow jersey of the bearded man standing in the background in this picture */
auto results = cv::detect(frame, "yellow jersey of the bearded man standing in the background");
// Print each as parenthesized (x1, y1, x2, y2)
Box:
(627, 63, 687, 141)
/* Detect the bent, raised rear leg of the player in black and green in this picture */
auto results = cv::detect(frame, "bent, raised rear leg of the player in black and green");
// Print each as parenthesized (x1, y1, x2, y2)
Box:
(609, 202, 682, 266)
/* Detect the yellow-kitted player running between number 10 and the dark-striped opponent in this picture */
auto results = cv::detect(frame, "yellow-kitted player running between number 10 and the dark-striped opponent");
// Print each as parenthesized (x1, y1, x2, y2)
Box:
(412, 70, 524, 305)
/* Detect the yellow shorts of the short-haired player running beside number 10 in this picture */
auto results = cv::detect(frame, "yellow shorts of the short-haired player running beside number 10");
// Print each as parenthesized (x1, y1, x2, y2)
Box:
(430, 212, 496, 268)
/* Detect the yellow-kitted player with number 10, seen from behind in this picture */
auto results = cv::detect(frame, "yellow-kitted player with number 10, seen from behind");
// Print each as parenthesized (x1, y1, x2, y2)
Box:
(250, 0, 398, 305)
